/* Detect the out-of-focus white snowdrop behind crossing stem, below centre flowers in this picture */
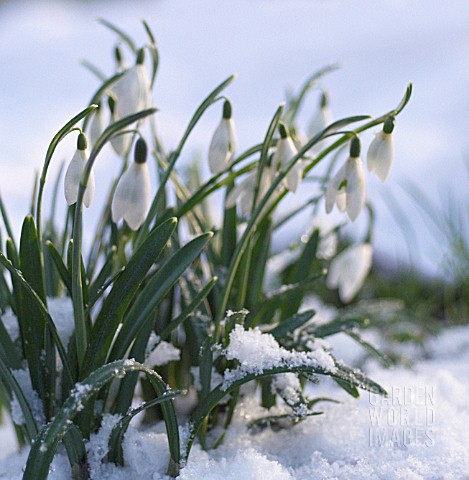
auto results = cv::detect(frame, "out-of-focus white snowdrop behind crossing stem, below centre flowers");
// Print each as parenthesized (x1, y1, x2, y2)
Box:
(225, 166, 275, 215)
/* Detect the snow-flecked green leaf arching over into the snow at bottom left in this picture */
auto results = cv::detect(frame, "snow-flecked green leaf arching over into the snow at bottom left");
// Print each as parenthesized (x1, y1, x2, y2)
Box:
(23, 360, 179, 480)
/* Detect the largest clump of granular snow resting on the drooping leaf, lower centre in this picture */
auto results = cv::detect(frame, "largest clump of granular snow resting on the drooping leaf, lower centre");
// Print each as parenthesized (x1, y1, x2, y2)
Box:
(222, 325, 335, 390)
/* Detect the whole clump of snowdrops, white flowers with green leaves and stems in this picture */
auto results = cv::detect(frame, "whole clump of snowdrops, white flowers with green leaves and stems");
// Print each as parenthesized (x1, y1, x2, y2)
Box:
(0, 21, 411, 479)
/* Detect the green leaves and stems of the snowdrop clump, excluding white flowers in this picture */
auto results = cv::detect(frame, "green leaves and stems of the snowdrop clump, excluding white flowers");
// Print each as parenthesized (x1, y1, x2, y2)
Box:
(0, 16, 411, 479)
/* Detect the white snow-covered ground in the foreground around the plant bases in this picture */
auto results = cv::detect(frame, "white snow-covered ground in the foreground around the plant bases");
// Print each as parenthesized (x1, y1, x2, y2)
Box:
(0, 320, 469, 480)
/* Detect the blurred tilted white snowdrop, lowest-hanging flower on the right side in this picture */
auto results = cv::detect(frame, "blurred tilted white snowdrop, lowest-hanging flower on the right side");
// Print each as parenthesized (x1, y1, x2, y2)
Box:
(326, 243, 373, 303)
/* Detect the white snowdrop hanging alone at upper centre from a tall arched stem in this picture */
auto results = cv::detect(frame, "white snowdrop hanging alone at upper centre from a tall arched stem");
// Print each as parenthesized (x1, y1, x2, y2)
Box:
(208, 100, 236, 175)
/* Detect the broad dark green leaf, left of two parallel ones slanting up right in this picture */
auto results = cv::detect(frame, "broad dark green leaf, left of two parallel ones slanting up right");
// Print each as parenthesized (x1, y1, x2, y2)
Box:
(83, 218, 177, 373)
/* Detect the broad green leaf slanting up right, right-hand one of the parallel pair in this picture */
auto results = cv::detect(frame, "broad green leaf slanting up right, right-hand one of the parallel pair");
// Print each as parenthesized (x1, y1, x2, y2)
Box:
(110, 232, 213, 360)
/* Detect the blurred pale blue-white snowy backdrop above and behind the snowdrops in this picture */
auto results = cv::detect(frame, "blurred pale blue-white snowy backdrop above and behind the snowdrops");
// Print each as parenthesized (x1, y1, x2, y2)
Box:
(0, 0, 469, 279)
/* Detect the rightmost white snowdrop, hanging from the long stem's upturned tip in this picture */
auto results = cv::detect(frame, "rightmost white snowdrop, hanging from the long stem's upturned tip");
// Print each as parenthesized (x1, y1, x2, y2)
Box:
(367, 115, 394, 182)
